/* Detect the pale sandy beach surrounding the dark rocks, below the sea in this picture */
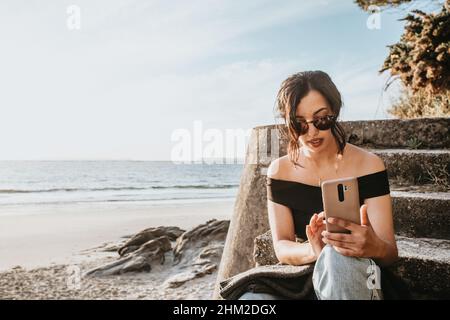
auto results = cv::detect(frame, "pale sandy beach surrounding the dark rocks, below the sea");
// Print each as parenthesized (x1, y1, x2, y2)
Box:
(0, 199, 234, 299)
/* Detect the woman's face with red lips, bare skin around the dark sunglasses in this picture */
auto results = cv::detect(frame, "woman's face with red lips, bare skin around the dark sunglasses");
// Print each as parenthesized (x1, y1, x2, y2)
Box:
(295, 90, 335, 153)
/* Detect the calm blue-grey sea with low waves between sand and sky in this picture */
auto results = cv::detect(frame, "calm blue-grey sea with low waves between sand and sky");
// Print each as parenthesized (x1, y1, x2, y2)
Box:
(0, 160, 243, 209)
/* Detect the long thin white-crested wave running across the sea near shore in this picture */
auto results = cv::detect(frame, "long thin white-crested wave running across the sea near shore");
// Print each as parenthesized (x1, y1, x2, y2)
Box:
(0, 184, 239, 194)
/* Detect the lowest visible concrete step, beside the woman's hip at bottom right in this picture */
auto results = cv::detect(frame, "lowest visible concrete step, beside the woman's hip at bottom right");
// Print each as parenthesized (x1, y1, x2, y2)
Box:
(389, 237, 450, 299)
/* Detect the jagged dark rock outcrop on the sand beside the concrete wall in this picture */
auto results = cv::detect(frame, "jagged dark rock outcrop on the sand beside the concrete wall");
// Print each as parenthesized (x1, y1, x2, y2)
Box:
(84, 219, 229, 288)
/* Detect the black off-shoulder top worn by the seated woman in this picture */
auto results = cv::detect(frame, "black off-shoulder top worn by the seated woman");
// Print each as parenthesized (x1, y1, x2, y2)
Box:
(266, 169, 390, 240)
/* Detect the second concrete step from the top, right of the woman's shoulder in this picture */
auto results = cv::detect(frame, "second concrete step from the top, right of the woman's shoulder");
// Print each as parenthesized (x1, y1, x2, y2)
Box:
(368, 149, 450, 191)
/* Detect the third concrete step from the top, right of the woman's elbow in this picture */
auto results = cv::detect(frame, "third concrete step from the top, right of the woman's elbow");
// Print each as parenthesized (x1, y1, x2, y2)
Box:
(391, 189, 450, 240)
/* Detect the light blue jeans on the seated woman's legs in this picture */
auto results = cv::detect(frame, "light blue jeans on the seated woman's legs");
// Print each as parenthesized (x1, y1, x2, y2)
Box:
(239, 245, 383, 300)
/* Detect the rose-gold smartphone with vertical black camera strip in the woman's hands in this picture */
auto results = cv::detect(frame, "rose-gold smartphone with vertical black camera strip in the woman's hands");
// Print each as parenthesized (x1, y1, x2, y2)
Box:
(320, 177, 361, 233)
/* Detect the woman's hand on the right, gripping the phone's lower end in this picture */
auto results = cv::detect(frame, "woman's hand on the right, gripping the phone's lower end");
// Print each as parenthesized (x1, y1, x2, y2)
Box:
(322, 204, 384, 258)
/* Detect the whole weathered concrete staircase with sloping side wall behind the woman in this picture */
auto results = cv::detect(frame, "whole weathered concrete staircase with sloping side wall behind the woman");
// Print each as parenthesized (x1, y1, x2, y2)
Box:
(214, 118, 450, 299)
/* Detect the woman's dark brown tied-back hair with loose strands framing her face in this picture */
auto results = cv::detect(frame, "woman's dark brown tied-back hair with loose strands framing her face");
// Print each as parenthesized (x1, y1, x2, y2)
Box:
(276, 71, 346, 166)
